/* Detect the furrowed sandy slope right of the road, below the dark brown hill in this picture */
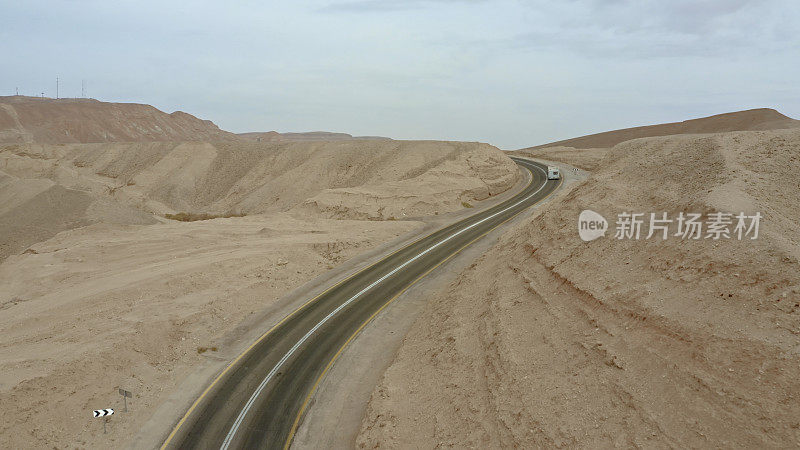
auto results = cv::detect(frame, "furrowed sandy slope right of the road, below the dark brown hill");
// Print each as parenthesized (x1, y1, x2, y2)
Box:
(358, 130, 800, 448)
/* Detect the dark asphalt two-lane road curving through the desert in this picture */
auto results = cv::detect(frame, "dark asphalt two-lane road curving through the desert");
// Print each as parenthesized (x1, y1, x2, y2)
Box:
(163, 158, 561, 449)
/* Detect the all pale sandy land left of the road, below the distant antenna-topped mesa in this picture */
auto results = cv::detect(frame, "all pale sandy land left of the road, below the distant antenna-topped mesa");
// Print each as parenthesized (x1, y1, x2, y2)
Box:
(0, 132, 519, 448)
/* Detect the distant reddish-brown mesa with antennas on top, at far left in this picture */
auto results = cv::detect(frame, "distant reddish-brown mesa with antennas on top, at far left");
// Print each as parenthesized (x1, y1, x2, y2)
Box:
(0, 96, 237, 144)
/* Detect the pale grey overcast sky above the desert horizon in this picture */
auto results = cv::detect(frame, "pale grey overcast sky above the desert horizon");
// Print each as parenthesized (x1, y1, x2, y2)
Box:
(0, 0, 800, 149)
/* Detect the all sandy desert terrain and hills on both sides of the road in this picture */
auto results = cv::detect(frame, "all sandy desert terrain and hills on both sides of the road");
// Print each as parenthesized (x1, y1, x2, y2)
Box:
(0, 97, 800, 449)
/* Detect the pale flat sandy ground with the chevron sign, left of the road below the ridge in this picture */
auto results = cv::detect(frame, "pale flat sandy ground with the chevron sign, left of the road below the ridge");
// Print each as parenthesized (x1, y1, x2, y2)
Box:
(0, 214, 417, 448)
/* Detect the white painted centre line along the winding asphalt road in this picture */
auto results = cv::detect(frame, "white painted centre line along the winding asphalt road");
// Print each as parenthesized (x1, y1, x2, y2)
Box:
(220, 165, 548, 450)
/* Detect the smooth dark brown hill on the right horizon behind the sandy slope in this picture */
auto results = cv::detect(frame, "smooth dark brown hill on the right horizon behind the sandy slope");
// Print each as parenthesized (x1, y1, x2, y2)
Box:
(520, 108, 800, 151)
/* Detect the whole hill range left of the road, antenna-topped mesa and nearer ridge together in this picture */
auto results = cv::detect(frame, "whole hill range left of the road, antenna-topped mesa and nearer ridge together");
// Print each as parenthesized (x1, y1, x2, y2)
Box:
(0, 96, 518, 259)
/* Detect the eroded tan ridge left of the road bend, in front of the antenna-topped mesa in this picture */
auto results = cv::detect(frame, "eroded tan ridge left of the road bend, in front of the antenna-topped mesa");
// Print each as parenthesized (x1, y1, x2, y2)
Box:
(0, 140, 518, 259)
